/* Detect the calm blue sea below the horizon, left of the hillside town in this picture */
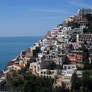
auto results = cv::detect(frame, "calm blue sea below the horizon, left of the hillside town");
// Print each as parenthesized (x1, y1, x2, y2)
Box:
(0, 36, 41, 70)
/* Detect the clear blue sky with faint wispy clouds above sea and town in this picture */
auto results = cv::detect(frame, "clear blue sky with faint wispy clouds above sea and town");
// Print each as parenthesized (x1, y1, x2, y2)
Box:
(0, 0, 92, 37)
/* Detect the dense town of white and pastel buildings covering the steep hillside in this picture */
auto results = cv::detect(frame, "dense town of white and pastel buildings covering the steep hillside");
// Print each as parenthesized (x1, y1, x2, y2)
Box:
(0, 9, 92, 89)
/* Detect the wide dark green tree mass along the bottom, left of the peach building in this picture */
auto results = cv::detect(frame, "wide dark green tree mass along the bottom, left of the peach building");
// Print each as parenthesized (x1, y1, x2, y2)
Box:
(7, 72, 54, 92)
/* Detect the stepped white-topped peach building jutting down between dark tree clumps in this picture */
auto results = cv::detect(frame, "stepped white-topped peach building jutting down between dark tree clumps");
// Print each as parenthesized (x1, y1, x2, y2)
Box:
(55, 64, 77, 89)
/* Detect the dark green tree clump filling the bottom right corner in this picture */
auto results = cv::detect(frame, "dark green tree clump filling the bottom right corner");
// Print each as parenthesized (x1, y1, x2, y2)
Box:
(71, 70, 92, 92)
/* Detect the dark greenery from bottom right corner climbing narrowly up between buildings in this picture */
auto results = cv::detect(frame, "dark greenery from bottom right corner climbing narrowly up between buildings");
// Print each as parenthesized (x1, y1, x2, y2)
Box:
(71, 42, 92, 92)
